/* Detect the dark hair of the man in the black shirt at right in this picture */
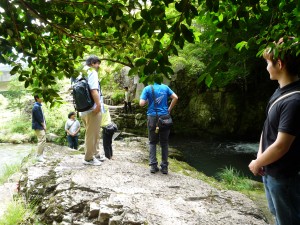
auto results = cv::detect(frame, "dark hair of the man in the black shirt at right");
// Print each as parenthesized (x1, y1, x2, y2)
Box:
(263, 37, 300, 76)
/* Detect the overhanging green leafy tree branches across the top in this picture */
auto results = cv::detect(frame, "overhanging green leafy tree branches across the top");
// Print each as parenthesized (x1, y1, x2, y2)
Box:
(0, 0, 300, 102)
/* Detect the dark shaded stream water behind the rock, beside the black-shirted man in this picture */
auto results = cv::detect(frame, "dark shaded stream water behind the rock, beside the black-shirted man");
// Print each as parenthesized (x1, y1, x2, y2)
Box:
(169, 137, 261, 181)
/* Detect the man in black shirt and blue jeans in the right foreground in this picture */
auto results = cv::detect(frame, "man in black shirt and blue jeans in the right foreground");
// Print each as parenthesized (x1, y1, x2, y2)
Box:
(249, 39, 300, 225)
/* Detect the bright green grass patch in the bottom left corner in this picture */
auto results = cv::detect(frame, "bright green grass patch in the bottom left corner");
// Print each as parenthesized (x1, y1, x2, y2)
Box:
(0, 199, 37, 225)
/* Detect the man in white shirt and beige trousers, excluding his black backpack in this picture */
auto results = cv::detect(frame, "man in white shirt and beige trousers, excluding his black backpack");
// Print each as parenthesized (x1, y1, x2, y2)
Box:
(80, 56, 101, 166)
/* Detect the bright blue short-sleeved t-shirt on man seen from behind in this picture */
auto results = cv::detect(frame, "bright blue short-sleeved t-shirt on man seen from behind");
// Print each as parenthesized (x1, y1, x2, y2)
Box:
(140, 83, 174, 116)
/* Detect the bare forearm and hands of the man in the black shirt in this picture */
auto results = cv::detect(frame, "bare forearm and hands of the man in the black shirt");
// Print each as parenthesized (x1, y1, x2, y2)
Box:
(249, 132, 295, 175)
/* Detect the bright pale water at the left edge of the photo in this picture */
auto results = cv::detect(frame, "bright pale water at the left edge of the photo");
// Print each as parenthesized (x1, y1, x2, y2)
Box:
(0, 143, 33, 176)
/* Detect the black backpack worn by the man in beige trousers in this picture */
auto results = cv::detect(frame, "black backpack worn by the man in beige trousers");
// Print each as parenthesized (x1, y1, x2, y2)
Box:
(72, 77, 94, 112)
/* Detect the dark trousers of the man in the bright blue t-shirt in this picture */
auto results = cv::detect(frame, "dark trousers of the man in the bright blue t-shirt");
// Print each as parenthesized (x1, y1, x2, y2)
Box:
(148, 116, 170, 167)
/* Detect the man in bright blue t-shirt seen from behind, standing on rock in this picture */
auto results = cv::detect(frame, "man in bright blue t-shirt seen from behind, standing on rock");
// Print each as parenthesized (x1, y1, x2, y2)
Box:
(140, 79, 178, 174)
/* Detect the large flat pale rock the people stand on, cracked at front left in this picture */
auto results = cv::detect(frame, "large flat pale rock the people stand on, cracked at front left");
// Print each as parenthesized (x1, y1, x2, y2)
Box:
(20, 138, 267, 225)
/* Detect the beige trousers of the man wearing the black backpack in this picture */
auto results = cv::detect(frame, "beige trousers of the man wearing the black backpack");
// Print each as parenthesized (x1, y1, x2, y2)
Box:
(82, 112, 101, 161)
